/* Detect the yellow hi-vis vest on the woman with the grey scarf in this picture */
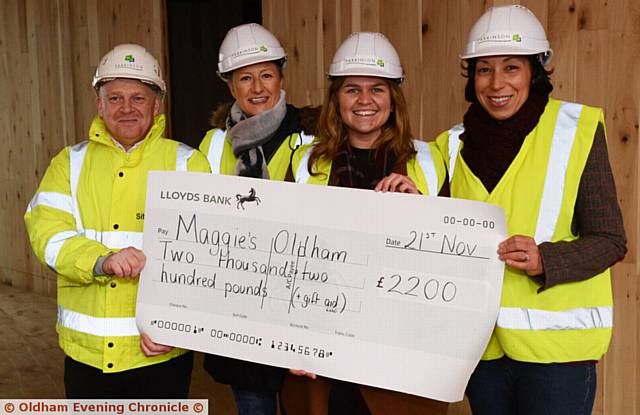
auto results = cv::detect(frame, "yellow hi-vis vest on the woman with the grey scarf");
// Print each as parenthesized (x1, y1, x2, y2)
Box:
(200, 128, 313, 180)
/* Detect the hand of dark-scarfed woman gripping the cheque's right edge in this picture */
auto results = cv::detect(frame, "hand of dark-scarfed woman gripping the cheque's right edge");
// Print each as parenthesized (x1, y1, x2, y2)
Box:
(498, 235, 544, 276)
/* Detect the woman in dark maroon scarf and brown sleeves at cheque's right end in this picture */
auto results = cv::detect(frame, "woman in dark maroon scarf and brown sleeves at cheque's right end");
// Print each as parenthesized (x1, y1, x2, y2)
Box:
(437, 5, 626, 415)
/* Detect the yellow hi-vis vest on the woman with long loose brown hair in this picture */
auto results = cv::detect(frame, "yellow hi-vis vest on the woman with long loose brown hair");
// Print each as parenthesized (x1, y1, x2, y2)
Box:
(292, 140, 446, 196)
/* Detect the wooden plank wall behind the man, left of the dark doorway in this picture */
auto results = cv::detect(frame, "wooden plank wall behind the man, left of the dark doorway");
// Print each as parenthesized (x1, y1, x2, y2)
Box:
(0, 0, 167, 295)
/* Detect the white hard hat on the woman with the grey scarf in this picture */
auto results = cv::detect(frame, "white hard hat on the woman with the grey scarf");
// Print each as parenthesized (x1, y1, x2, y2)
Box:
(218, 23, 287, 79)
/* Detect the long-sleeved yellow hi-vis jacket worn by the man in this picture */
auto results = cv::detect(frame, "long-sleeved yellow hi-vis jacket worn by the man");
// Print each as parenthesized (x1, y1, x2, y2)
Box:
(24, 115, 209, 372)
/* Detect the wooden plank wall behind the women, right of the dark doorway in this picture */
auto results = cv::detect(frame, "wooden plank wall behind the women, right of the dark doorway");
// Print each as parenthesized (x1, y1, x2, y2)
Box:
(262, 0, 640, 415)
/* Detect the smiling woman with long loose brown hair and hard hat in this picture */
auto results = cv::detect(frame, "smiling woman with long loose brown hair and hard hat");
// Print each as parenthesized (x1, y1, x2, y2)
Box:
(292, 32, 448, 415)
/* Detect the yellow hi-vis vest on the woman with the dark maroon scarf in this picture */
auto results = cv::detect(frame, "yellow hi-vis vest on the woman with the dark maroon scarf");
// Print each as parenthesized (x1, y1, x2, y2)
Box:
(436, 99, 613, 363)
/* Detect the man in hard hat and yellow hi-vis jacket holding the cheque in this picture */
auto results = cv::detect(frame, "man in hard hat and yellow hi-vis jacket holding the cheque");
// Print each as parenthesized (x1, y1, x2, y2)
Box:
(25, 44, 209, 398)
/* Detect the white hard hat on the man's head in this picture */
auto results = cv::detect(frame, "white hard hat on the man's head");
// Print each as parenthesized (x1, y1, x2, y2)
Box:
(91, 44, 165, 94)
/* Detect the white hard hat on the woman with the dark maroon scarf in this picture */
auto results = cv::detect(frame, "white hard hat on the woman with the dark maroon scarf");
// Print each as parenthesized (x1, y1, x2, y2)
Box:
(460, 5, 553, 65)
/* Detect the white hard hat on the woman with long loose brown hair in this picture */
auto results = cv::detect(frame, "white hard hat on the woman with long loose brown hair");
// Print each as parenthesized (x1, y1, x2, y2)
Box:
(327, 32, 404, 82)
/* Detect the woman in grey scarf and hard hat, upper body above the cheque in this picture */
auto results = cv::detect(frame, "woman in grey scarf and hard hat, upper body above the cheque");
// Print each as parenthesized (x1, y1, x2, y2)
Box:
(200, 23, 315, 184)
